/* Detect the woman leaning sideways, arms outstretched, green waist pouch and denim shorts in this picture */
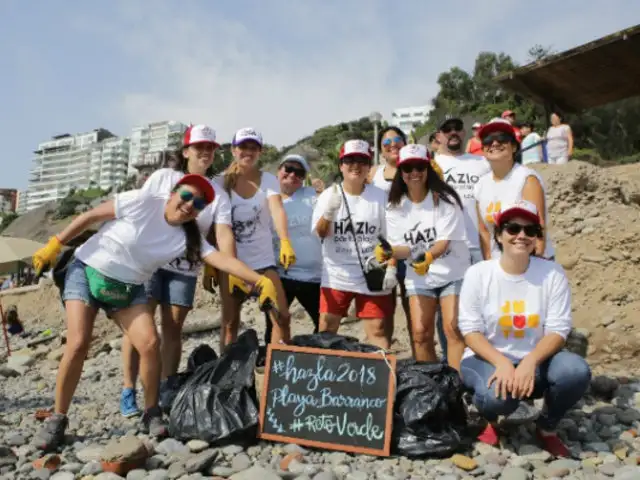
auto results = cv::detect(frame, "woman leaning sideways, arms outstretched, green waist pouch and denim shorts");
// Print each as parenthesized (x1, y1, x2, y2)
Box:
(33, 175, 276, 450)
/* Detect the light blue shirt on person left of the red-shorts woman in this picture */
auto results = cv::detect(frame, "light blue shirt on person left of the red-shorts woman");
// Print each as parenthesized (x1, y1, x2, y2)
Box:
(273, 187, 322, 283)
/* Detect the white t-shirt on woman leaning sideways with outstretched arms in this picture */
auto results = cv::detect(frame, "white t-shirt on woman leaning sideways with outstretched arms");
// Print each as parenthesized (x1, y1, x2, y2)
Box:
(75, 190, 215, 285)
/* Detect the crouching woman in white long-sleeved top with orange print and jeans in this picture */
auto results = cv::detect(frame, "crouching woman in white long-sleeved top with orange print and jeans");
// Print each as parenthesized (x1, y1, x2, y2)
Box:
(458, 200, 591, 456)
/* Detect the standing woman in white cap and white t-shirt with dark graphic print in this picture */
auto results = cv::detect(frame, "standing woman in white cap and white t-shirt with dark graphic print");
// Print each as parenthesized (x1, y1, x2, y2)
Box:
(216, 128, 296, 345)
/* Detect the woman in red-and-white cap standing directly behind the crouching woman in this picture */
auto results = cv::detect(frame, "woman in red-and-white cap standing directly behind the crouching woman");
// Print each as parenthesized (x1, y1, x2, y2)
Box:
(474, 118, 554, 260)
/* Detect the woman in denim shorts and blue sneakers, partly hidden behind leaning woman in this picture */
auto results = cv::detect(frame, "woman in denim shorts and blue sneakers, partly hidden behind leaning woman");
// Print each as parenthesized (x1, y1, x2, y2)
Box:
(120, 125, 235, 417)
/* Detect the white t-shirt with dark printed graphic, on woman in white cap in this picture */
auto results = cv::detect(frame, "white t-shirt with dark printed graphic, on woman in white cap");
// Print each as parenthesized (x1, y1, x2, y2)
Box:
(214, 172, 280, 270)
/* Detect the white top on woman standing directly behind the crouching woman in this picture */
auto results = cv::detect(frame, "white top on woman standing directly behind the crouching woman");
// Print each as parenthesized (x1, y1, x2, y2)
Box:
(474, 163, 555, 258)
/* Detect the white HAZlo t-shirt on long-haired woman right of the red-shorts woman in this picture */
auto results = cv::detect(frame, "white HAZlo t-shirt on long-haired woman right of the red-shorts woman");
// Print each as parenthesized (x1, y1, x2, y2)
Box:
(386, 194, 471, 288)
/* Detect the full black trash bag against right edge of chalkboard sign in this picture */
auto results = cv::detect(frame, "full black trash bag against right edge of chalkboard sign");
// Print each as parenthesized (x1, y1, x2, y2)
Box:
(392, 360, 473, 458)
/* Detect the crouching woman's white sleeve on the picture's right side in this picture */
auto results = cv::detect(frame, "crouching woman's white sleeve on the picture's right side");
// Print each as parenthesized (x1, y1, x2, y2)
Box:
(544, 264, 573, 340)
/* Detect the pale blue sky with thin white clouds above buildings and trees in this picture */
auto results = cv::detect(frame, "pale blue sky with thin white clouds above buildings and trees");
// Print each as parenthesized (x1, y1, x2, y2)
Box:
(0, 0, 640, 189)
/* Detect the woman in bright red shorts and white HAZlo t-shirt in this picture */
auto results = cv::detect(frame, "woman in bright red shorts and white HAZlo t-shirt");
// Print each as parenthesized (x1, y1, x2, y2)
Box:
(311, 140, 397, 349)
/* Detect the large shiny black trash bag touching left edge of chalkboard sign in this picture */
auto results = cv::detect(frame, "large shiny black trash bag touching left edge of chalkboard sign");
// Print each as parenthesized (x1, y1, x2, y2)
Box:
(169, 330, 259, 446)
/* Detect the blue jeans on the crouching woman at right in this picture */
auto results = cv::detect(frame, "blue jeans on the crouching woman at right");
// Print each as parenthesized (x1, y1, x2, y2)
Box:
(461, 350, 591, 430)
